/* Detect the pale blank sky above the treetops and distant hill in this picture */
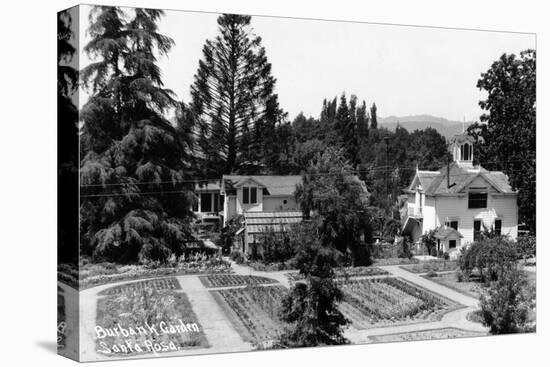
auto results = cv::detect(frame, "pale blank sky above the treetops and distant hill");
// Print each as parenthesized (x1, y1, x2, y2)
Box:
(80, 6, 536, 121)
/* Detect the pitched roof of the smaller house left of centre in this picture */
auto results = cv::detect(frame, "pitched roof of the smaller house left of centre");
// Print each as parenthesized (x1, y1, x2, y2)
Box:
(222, 175, 302, 196)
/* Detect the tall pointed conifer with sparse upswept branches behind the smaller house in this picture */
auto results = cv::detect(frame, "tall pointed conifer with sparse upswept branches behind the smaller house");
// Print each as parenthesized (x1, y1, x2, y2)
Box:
(191, 14, 284, 177)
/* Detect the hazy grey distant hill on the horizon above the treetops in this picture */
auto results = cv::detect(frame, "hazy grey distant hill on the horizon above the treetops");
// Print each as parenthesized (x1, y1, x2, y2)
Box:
(378, 115, 473, 138)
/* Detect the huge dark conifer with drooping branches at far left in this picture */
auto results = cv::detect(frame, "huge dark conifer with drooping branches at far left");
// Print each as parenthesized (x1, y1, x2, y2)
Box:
(80, 6, 193, 263)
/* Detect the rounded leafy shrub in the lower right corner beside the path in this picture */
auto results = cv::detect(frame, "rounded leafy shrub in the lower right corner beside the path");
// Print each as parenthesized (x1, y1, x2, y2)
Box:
(480, 266, 535, 334)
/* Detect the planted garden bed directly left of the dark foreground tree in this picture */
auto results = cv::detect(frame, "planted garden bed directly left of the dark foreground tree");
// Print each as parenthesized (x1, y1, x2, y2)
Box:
(212, 286, 287, 348)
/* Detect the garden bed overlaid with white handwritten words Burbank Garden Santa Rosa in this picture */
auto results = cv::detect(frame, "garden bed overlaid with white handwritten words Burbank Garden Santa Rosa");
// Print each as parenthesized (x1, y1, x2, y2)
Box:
(95, 278, 208, 357)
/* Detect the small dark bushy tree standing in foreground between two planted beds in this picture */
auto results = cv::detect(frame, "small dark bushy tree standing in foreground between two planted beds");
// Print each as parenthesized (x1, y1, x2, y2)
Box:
(280, 218, 347, 347)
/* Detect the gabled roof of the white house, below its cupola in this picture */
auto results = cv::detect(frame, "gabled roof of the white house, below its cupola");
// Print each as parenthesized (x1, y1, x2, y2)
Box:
(406, 162, 515, 196)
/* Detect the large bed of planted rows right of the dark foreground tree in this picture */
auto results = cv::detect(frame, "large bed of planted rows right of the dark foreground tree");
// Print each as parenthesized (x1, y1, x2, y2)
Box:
(340, 277, 459, 329)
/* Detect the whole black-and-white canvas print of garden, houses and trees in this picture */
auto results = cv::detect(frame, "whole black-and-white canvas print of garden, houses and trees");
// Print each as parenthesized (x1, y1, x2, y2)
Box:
(52, 3, 537, 363)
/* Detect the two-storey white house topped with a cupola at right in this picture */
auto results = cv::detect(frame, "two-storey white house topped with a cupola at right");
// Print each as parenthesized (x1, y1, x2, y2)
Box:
(402, 134, 518, 258)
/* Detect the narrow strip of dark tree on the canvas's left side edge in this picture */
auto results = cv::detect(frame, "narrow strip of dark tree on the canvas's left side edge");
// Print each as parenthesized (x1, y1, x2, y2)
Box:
(57, 10, 78, 264)
